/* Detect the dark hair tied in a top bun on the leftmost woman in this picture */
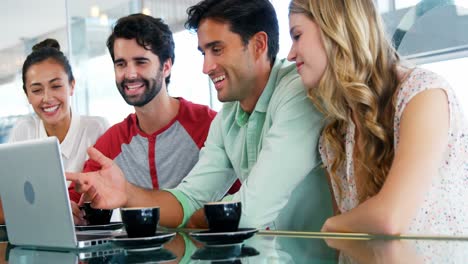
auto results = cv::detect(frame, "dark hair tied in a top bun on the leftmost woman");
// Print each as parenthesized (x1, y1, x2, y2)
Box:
(23, 39, 75, 94)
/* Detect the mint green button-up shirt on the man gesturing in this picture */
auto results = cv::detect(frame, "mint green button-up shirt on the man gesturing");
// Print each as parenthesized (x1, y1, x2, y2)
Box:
(166, 59, 332, 231)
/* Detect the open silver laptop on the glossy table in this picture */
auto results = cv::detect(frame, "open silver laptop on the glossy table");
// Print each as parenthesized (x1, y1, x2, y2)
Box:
(0, 137, 111, 249)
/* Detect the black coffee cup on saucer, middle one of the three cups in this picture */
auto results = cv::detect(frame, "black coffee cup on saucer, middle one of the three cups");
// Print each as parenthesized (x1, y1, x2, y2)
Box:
(120, 207, 159, 237)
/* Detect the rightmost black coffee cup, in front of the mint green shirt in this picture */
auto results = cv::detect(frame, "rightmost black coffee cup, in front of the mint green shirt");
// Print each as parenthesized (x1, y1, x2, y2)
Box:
(204, 202, 242, 232)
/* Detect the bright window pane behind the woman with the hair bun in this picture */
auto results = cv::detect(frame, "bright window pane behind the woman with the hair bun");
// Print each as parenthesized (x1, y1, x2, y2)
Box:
(0, 0, 68, 118)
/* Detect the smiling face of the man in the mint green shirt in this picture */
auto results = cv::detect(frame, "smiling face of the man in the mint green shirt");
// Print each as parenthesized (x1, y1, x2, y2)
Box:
(197, 19, 256, 102)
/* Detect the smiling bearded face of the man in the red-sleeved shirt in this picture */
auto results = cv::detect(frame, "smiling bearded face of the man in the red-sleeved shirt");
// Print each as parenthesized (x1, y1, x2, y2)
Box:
(114, 38, 171, 107)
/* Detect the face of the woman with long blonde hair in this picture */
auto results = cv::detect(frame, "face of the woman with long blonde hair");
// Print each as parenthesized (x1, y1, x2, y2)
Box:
(288, 13, 328, 88)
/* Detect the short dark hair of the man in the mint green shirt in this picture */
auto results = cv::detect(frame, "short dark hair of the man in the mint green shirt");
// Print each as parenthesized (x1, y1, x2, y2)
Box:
(185, 0, 279, 64)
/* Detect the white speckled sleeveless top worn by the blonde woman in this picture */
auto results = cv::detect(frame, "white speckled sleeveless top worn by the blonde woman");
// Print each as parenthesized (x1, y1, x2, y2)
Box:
(319, 68, 468, 235)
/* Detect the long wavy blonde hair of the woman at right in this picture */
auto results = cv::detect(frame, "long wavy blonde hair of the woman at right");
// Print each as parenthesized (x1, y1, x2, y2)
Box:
(289, 0, 399, 202)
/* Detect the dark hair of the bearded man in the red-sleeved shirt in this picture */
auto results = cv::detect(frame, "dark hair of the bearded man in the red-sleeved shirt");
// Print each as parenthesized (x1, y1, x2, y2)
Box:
(107, 14, 175, 85)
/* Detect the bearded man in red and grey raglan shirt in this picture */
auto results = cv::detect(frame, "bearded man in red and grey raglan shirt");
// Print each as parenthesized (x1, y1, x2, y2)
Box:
(69, 14, 239, 223)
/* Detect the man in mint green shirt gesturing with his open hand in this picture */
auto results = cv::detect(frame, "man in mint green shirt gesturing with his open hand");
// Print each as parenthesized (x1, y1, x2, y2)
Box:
(67, 0, 332, 231)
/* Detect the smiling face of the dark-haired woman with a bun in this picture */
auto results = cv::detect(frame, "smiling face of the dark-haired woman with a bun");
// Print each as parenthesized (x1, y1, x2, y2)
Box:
(25, 59, 75, 127)
